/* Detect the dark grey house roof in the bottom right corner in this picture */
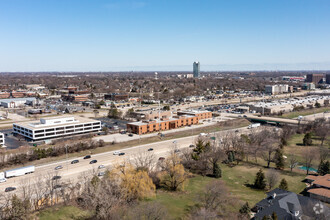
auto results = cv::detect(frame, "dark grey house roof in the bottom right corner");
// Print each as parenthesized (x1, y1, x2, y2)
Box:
(255, 188, 330, 220)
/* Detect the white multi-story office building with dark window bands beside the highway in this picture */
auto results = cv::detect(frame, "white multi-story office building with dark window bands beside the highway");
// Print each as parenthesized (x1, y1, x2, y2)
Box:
(13, 116, 101, 141)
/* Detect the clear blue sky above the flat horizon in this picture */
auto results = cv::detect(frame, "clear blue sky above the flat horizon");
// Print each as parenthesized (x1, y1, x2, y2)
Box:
(0, 0, 330, 72)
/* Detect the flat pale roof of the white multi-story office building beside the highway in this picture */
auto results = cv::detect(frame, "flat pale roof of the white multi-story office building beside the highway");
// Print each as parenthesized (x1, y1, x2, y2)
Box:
(13, 116, 99, 130)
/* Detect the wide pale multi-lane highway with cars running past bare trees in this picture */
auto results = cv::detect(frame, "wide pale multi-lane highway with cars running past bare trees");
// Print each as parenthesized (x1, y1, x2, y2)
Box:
(0, 127, 249, 199)
